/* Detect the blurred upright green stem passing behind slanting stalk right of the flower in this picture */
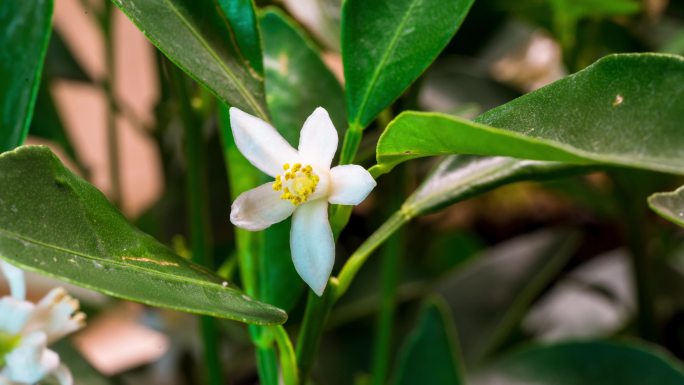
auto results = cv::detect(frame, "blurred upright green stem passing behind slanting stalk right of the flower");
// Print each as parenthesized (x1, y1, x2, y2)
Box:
(371, 167, 405, 385)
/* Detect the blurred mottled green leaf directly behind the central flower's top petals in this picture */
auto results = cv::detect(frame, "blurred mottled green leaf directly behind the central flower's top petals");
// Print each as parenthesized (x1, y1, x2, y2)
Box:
(260, 8, 346, 148)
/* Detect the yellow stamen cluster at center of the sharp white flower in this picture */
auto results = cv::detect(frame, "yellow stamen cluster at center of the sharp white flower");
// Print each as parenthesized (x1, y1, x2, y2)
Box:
(273, 163, 320, 206)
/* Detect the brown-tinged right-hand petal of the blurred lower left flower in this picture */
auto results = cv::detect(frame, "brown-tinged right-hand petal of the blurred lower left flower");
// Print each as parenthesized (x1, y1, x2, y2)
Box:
(25, 287, 85, 344)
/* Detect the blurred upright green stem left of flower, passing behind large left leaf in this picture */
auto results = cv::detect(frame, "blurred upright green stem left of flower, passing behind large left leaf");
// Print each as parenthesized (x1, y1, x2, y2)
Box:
(170, 67, 223, 385)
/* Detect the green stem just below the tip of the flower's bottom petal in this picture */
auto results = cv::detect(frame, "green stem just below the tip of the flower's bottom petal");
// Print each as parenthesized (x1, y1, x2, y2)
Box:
(297, 280, 336, 385)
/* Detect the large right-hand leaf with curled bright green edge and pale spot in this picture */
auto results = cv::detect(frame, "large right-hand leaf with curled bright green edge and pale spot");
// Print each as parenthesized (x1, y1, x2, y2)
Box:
(374, 54, 684, 175)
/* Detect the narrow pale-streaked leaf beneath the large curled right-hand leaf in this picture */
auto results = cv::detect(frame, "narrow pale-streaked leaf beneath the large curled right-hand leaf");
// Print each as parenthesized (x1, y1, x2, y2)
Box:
(402, 155, 587, 217)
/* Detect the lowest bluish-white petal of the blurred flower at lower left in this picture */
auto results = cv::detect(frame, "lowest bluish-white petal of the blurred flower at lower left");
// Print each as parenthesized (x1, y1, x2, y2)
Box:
(3, 332, 59, 384)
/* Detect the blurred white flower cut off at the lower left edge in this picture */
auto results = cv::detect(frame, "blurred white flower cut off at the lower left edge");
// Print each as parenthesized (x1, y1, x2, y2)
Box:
(0, 260, 85, 385)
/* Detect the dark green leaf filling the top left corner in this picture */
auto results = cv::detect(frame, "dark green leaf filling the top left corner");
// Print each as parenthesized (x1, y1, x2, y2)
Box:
(0, 0, 52, 152)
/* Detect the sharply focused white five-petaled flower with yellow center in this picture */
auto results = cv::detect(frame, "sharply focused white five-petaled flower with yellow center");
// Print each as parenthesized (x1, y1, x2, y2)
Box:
(230, 107, 376, 296)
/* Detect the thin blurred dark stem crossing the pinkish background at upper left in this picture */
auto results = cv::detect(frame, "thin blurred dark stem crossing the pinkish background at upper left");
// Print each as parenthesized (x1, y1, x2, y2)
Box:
(101, 1, 122, 207)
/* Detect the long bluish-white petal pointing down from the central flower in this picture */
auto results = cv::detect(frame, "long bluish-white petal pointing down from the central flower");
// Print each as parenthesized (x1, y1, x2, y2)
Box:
(290, 199, 335, 296)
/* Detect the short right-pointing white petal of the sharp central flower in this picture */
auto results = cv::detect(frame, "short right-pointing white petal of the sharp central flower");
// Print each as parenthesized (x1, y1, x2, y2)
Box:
(328, 164, 377, 205)
